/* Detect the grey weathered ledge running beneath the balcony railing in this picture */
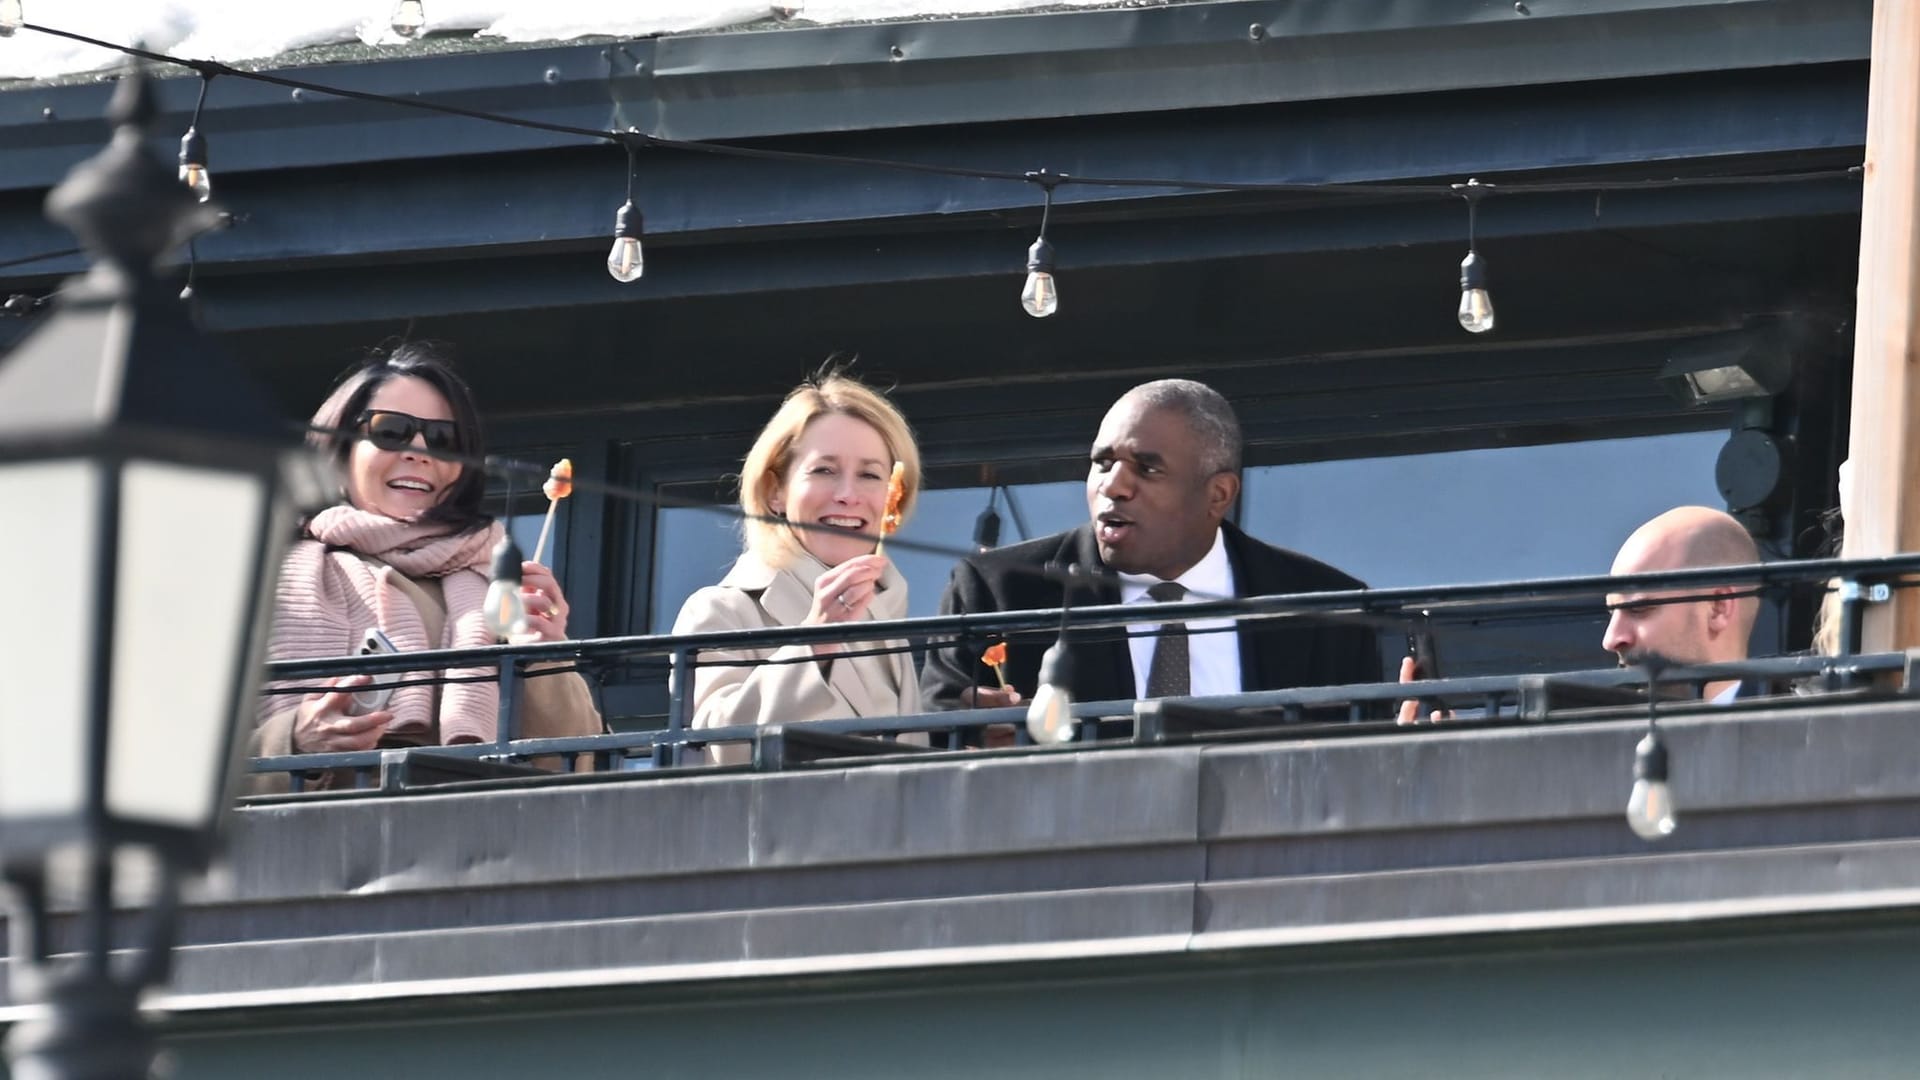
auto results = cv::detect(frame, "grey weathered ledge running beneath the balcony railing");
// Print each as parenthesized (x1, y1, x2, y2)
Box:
(3, 691, 1920, 1003)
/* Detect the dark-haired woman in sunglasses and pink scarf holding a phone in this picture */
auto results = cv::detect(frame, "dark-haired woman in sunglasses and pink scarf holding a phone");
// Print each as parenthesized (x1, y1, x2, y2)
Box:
(253, 342, 601, 782)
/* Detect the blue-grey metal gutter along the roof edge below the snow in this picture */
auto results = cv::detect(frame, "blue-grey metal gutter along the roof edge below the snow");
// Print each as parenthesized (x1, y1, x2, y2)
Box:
(0, 0, 1872, 190)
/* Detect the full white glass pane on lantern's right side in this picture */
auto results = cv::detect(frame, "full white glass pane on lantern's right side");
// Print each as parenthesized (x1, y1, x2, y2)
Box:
(106, 461, 269, 828)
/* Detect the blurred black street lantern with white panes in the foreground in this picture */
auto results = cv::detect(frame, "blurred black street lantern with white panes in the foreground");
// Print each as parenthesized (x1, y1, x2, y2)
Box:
(0, 62, 319, 1080)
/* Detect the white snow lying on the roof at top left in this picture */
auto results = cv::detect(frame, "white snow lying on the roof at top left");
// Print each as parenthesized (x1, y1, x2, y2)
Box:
(0, 0, 1136, 81)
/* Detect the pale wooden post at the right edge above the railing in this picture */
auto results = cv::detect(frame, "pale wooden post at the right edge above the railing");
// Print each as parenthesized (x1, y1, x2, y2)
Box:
(1845, 0, 1920, 651)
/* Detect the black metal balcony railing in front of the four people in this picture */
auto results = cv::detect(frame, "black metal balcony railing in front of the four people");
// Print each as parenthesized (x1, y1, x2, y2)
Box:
(248, 555, 1920, 790)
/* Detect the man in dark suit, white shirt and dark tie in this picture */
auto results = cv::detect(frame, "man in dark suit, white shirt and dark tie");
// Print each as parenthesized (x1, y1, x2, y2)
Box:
(920, 379, 1382, 709)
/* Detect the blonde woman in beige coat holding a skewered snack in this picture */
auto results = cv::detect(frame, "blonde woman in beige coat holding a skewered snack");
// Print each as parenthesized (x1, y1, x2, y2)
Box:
(674, 375, 920, 763)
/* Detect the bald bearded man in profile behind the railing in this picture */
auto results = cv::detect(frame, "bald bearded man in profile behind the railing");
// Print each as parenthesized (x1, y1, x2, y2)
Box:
(1601, 505, 1761, 705)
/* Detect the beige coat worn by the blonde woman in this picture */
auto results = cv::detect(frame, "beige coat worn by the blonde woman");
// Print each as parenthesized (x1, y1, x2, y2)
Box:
(674, 552, 925, 765)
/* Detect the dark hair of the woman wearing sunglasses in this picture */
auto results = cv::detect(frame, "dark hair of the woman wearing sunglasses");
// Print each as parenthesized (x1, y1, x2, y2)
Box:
(307, 342, 493, 532)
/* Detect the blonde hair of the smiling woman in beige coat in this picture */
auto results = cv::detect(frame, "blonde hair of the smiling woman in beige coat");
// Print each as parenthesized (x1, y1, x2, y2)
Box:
(739, 371, 920, 567)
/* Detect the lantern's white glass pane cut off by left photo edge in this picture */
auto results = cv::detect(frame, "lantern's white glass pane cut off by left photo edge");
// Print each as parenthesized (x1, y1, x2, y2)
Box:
(0, 461, 102, 821)
